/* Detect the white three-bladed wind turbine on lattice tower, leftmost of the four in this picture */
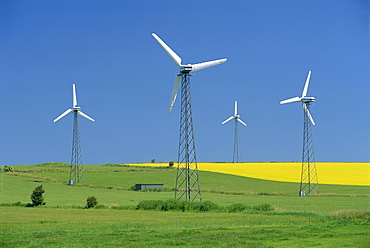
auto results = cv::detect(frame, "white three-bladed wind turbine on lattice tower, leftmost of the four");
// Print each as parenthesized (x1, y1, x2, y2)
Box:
(54, 84, 95, 185)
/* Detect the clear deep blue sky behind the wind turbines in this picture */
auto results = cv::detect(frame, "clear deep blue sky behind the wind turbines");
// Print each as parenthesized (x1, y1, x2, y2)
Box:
(0, 0, 370, 165)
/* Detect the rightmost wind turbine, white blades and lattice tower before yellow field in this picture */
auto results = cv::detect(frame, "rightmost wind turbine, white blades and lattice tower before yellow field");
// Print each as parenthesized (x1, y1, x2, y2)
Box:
(280, 71, 319, 196)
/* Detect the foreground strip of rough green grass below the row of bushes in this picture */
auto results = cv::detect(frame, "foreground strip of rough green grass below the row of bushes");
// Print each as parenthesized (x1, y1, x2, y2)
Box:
(0, 207, 370, 247)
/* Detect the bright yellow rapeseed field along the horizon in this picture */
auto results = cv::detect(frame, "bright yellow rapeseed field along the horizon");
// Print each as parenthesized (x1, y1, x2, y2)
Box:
(135, 162, 370, 186)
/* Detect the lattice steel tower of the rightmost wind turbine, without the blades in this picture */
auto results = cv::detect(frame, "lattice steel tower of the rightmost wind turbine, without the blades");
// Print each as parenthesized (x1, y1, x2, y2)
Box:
(299, 102, 319, 196)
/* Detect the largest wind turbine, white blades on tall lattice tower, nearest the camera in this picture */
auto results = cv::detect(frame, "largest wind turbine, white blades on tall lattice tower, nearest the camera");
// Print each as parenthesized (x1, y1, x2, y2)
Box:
(152, 33, 227, 201)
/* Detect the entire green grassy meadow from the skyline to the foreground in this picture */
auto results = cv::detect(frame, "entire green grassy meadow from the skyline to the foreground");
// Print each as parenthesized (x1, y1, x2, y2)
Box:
(0, 163, 370, 247)
